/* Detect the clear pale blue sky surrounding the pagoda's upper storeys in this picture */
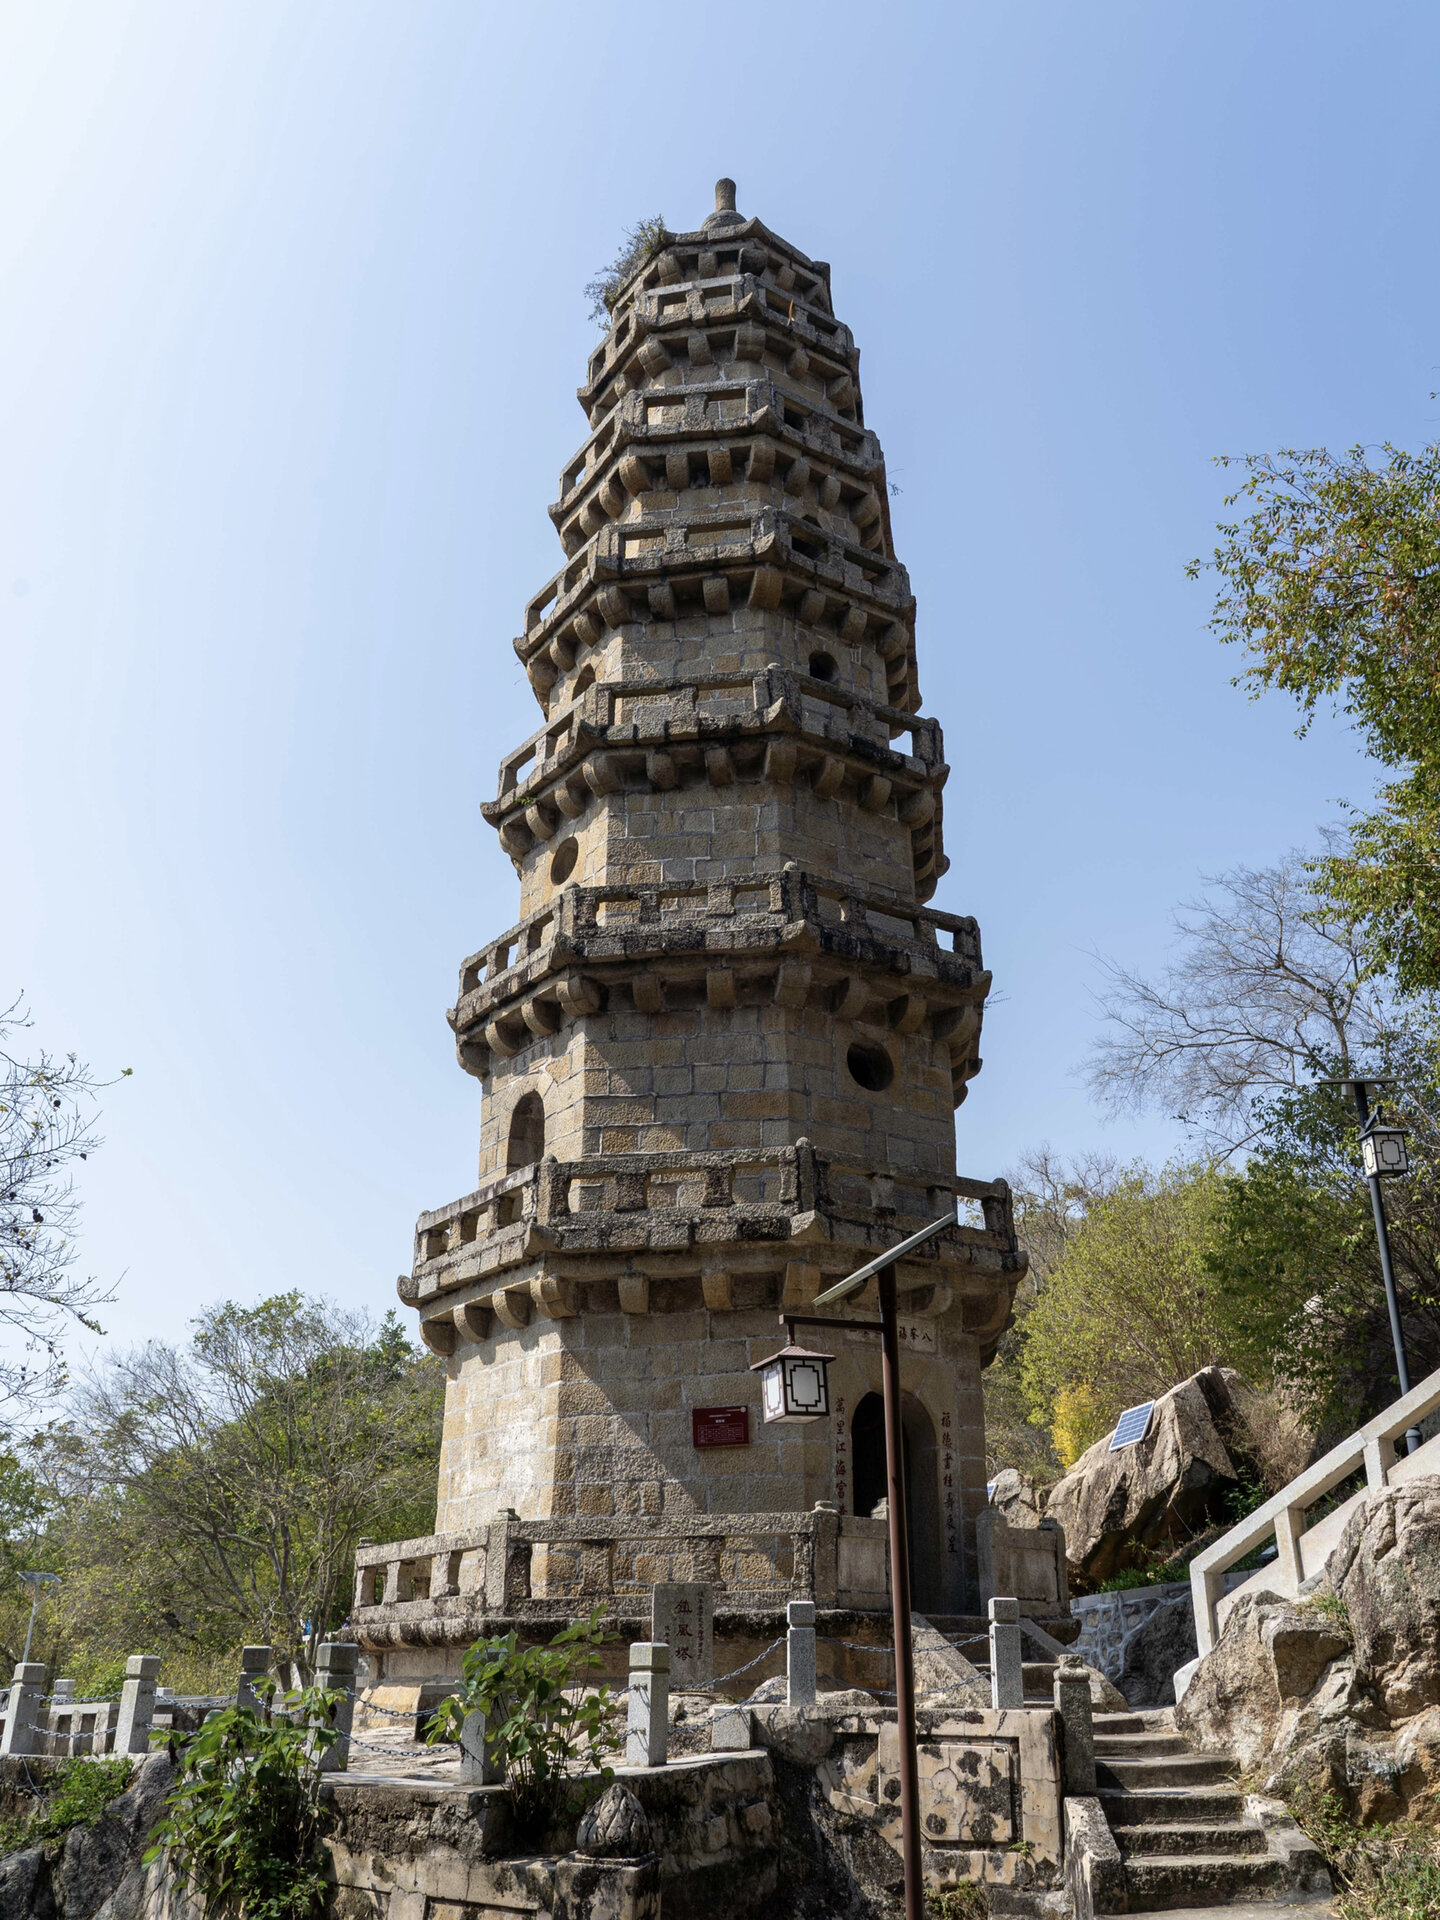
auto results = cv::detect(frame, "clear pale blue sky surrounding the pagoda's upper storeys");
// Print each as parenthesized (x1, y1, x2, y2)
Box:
(0, 0, 1440, 1338)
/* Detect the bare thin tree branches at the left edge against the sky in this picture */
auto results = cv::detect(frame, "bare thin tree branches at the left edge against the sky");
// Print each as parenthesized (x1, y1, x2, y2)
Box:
(0, 998, 131, 1427)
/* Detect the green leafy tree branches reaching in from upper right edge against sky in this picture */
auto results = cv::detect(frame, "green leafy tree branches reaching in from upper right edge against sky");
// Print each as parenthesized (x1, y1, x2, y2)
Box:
(1190, 444, 1440, 993)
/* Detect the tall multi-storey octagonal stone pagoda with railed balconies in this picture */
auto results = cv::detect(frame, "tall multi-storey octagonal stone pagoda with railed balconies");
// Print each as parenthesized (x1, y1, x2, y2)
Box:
(353, 180, 1025, 1678)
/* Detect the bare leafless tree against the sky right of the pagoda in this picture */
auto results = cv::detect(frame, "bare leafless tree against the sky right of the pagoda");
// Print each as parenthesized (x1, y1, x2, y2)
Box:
(1087, 835, 1405, 1154)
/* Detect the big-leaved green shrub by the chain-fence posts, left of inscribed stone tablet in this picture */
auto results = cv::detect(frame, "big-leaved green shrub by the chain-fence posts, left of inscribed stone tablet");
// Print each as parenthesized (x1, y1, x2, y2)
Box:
(428, 1611, 614, 1841)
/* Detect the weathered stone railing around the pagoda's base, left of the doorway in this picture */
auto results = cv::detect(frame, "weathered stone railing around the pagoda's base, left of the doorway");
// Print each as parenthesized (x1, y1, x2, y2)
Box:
(351, 1505, 887, 1640)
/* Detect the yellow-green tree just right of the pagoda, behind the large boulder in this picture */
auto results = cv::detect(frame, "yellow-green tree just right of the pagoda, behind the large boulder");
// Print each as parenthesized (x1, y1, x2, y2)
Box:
(1021, 1164, 1225, 1465)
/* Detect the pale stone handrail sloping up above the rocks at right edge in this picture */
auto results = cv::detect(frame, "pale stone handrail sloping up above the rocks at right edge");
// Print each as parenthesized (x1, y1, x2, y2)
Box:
(1190, 1369, 1440, 1657)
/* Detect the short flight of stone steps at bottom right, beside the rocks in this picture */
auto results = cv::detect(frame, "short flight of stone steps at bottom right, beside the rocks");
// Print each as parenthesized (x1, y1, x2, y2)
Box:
(1094, 1707, 1331, 1914)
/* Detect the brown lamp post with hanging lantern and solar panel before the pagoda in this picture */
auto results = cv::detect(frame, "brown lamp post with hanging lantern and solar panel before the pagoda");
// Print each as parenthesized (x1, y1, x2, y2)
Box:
(753, 1213, 954, 1920)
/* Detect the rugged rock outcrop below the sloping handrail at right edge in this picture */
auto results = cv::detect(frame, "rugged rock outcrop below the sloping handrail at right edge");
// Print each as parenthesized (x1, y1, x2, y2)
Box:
(1175, 1476, 1440, 1822)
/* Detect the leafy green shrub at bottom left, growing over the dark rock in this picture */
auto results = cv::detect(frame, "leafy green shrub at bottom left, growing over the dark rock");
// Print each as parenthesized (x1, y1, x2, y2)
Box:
(144, 1682, 344, 1920)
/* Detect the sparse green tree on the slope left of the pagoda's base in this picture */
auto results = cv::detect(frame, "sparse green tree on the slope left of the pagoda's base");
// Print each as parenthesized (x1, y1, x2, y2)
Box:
(46, 1294, 444, 1676)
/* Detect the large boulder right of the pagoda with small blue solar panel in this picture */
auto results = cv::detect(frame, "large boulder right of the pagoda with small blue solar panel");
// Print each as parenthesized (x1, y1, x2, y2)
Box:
(1044, 1367, 1242, 1584)
